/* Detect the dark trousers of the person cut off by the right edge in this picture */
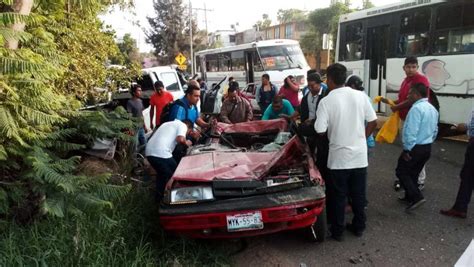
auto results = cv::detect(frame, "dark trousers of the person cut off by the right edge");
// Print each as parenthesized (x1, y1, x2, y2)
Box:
(453, 138, 474, 212)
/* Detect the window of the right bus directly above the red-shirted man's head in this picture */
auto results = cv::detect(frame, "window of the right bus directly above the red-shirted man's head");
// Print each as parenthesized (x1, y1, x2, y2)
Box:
(397, 9, 431, 56)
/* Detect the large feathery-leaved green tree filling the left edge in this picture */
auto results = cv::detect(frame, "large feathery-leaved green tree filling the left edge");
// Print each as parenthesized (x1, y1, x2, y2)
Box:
(0, 0, 131, 224)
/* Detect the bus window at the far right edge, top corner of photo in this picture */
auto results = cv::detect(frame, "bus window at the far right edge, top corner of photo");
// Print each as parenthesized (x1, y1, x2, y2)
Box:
(433, 4, 474, 54)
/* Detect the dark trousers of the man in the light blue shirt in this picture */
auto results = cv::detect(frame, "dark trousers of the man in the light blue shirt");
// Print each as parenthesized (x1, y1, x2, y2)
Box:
(395, 144, 431, 202)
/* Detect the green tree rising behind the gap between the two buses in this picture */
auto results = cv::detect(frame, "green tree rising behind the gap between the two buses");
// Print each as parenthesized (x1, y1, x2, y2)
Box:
(301, 3, 351, 69)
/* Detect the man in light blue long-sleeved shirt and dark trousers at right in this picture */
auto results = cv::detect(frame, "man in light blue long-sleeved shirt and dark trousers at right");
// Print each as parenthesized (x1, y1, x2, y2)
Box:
(396, 83, 439, 212)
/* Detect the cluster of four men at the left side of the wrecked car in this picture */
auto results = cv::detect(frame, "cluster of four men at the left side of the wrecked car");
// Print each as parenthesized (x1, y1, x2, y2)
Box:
(127, 80, 210, 199)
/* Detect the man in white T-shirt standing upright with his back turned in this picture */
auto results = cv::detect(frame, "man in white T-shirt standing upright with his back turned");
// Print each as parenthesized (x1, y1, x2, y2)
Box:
(314, 63, 377, 241)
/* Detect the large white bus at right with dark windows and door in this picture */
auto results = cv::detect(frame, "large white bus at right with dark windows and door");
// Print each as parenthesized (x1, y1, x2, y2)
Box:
(336, 0, 474, 124)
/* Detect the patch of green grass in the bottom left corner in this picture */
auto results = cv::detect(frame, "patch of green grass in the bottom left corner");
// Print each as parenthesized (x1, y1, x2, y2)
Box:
(0, 188, 230, 266)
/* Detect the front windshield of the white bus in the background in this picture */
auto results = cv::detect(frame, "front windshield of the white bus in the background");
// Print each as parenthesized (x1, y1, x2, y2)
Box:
(258, 45, 308, 70)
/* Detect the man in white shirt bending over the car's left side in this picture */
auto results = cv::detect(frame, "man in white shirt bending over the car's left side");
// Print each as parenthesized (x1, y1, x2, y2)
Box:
(145, 120, 193, 199)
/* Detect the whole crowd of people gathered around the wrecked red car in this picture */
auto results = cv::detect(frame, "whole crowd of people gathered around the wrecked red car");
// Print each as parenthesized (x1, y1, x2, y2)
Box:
(127, 57, 474, 240)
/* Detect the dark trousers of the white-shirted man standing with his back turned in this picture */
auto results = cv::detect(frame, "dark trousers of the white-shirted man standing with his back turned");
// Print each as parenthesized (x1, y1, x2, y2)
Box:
(327, 168, 367, 236)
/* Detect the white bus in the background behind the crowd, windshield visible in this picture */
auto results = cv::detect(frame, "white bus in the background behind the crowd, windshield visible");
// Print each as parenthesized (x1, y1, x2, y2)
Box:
(195, 39, 309, 89)
